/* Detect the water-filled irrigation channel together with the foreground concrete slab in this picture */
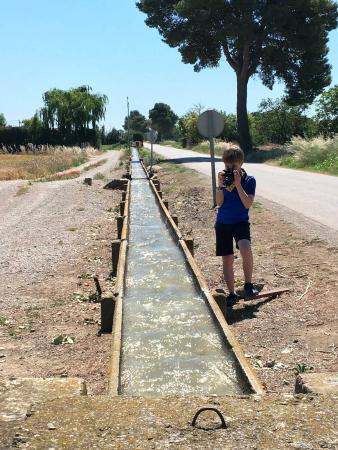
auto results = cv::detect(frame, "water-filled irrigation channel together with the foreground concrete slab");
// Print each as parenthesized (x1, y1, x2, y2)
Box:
(0, 152, 338, 450)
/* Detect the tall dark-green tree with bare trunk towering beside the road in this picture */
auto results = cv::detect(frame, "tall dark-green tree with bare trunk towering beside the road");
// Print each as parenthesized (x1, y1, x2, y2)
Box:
(137, 0, 337, 152)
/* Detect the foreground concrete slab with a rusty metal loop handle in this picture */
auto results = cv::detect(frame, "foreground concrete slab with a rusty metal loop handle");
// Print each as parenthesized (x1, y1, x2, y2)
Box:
(0, 395, 338, 450)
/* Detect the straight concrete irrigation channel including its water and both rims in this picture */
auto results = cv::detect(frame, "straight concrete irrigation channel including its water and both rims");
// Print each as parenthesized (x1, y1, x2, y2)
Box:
(110, 149, 263, 396)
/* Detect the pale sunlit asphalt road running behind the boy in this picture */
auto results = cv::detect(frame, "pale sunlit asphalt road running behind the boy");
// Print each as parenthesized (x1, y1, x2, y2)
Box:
(145, 144, 338, 231)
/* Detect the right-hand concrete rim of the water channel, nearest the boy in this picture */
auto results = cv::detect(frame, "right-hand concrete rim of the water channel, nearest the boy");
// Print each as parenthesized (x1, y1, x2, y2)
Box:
(141, 157, 265, 395)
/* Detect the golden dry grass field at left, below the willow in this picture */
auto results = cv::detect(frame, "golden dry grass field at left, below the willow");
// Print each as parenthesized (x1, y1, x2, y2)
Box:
(0, 147, 96, 180)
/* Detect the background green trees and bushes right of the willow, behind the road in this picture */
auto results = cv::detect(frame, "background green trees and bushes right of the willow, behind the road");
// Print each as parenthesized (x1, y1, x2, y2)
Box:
(103, 85, 338, 147)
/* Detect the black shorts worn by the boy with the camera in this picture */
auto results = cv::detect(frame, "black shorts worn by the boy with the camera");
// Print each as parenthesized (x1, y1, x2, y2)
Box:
(215, 222, 251, 256)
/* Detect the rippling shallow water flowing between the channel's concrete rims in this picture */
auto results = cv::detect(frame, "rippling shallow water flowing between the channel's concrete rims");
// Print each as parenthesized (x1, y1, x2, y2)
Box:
(120, 150, 245, 396)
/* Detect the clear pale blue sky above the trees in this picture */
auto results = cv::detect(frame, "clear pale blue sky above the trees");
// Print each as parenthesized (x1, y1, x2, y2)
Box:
(0, 0, 338, 128)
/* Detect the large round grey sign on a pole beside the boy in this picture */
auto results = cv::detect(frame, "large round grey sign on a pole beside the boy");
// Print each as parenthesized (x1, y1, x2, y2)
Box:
(197, 109, 224, 207)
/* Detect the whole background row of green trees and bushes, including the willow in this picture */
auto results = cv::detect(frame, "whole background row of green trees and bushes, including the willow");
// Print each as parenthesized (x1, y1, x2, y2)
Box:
(0, 85, 338, 151)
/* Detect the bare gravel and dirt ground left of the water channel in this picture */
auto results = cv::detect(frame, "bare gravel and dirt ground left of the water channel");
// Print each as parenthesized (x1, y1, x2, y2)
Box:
(0, 152, 124, 391)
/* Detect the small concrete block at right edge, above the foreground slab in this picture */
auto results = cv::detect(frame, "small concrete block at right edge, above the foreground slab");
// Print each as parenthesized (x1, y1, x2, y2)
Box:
(295, 372, 338, 396)
